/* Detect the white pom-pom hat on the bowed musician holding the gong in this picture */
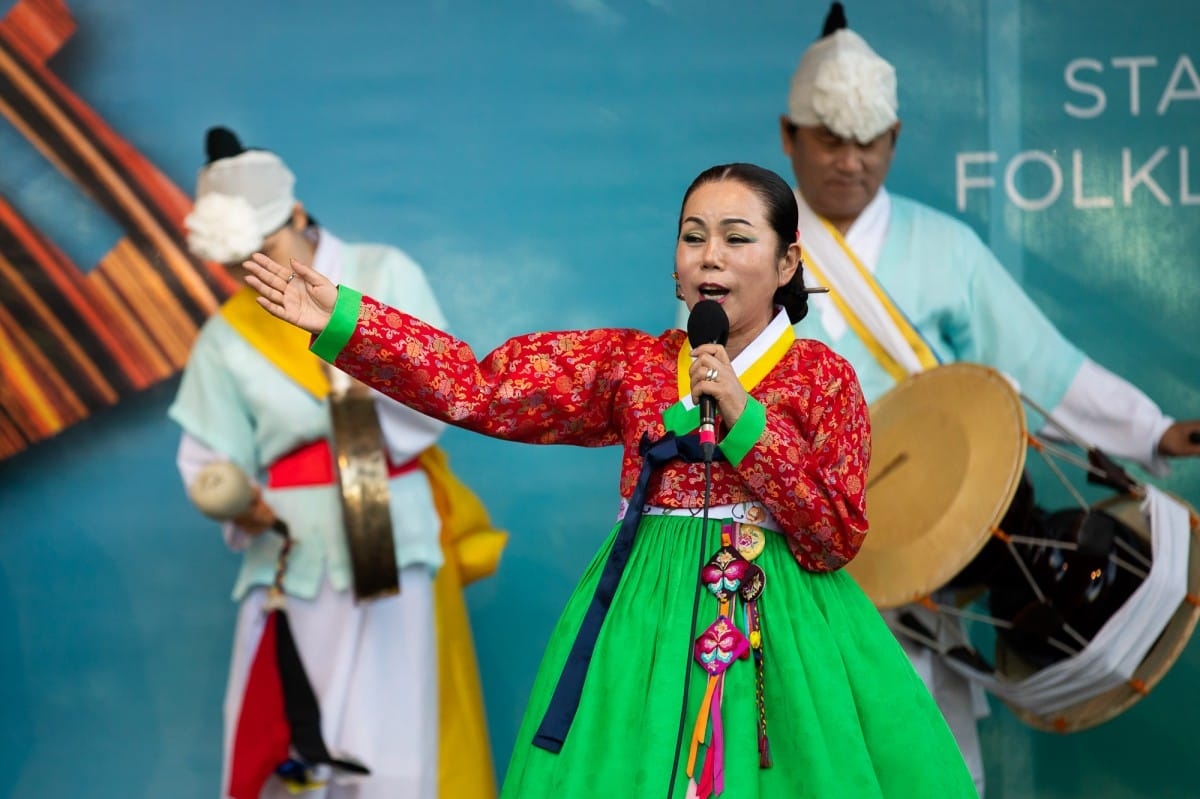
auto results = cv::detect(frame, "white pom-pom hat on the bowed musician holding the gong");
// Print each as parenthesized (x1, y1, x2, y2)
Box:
(184, 128, 296, 264)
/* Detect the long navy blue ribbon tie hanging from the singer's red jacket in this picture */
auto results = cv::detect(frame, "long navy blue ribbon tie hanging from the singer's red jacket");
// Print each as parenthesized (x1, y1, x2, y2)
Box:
(533, 432, 725, 752)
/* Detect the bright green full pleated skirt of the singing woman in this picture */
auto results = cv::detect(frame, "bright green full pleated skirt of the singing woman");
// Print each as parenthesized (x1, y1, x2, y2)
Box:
(500, 516, 976, 799)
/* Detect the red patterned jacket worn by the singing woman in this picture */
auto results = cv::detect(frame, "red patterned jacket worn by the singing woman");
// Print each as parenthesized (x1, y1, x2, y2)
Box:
(324, 288, 870, 571)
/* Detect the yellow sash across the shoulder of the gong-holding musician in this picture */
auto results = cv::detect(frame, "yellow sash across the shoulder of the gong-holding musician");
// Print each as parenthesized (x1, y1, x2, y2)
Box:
(221, 286, 329, 400)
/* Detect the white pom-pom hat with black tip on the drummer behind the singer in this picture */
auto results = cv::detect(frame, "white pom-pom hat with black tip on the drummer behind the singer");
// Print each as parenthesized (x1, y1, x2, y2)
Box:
(787, 4, 899, 144)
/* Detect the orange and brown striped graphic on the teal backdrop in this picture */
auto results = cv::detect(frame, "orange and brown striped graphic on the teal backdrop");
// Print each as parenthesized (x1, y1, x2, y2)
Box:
(0, 0, 234, 459)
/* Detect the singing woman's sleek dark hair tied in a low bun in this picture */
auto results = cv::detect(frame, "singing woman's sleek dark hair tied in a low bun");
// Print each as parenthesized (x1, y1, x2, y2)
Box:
(677, 163, 809, 324)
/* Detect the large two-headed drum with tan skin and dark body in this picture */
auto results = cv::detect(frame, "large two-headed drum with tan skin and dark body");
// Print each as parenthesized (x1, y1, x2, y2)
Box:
(847, 364, 1200, 732)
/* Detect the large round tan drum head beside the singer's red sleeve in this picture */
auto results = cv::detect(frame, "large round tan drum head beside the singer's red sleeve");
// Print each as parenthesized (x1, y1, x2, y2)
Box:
(846, 364, 1026, 608)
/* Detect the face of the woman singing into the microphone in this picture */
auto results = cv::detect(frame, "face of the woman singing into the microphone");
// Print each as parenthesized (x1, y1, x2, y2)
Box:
(676, 180, 799, 356)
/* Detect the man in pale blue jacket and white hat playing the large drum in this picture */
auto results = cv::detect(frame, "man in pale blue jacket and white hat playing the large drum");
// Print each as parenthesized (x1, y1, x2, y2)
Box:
(780, 2, 1200, 795)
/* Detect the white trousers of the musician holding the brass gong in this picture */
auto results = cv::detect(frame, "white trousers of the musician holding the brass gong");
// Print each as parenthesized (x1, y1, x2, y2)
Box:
(221, 566, 438, 799)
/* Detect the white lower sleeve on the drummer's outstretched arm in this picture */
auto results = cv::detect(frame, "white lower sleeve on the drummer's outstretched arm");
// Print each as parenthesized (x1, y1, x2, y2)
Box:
(1038, 358, 1175, 476)
